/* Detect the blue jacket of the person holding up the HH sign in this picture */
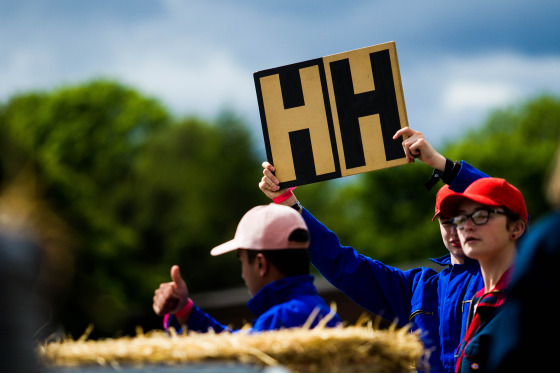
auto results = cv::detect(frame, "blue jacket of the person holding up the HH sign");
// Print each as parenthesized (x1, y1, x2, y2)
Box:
(303, 162, 487, 372)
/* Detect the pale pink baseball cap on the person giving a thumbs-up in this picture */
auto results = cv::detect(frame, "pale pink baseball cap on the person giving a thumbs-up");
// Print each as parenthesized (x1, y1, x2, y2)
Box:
(210, 204, 309, 256)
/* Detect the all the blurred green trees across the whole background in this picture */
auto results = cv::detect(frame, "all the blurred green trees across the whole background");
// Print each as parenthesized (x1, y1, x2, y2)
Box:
(0, 80, 560, 337)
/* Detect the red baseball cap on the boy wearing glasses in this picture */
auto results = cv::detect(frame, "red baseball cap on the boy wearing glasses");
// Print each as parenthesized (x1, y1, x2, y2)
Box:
(440, 178, 529, 222)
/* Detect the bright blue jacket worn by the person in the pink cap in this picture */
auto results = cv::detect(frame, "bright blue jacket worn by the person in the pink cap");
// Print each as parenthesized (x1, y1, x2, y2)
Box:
(167, 275, 341, 332)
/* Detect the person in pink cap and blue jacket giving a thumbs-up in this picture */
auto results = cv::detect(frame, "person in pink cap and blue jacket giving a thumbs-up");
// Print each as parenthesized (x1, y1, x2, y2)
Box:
(153, 204, 341, 332)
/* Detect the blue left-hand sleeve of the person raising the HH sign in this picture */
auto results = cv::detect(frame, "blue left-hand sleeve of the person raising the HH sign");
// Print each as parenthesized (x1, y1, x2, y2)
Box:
(302, 209, 428, 325)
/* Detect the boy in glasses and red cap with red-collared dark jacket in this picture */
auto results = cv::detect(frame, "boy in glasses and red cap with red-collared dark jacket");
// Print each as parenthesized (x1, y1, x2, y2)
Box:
(441, 178, 529, 372)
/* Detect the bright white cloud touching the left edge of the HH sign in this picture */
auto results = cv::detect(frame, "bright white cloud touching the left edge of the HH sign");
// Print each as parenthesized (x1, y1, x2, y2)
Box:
(113, 49, 256, 116)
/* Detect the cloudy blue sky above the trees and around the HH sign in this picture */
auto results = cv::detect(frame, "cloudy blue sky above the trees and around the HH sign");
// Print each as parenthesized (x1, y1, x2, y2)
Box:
(0, 0, 560, 152)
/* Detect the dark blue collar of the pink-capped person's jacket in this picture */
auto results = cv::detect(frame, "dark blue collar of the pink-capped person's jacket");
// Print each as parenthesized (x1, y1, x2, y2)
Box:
(247, 275, 317, 317)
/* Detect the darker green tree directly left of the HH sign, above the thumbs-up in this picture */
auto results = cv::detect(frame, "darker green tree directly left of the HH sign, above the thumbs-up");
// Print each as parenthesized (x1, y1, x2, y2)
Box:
(123, 113, 267, 306)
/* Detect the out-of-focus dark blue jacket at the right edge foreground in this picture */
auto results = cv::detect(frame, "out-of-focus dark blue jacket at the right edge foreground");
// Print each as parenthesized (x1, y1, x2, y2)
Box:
(488, 212, 560, 373)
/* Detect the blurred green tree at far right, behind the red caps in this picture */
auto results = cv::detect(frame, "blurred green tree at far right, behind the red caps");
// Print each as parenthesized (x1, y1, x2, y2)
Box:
(445, 95, 560, 220)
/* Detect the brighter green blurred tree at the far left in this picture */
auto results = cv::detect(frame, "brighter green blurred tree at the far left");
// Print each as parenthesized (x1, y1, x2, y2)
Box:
(0, 81, 170, 333)
